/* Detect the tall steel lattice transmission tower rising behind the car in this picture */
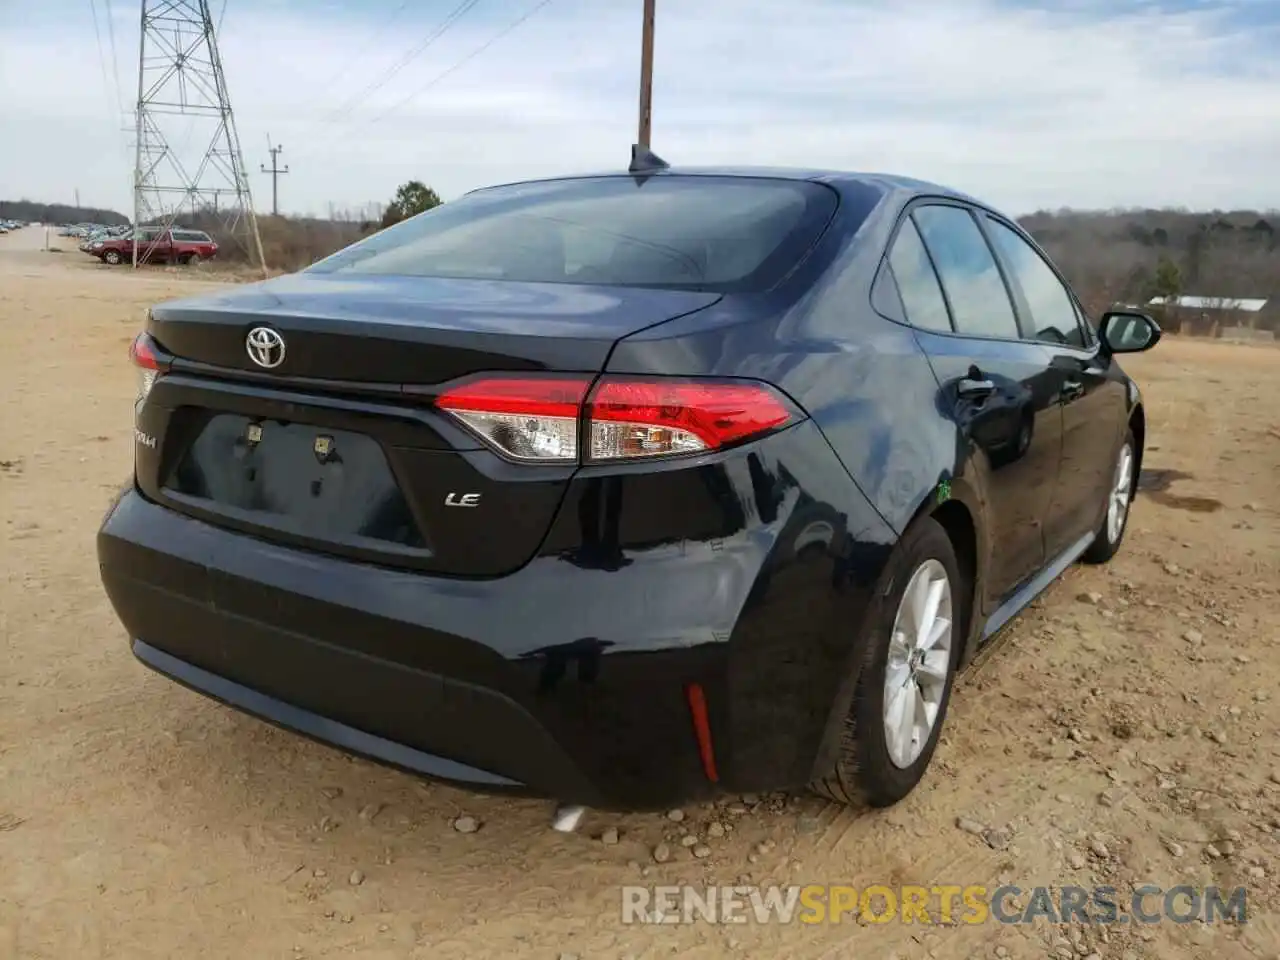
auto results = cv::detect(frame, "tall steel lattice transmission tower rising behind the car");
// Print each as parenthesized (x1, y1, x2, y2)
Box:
(133, 0, 266, 271)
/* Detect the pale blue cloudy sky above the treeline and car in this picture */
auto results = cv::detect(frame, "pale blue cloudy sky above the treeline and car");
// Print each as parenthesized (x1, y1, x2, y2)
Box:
(0, 0, 1280, 214)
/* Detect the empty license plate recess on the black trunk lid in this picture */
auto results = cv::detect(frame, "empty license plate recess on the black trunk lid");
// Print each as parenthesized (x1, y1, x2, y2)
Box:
(165, 413, 425, 549)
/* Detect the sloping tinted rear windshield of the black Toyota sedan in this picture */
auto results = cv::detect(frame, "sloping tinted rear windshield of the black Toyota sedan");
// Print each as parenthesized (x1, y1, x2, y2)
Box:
(308, 175, 837, 292)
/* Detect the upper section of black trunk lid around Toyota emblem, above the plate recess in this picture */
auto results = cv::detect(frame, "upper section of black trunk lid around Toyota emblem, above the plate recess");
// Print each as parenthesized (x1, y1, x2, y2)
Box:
(148, 274, 719, 385)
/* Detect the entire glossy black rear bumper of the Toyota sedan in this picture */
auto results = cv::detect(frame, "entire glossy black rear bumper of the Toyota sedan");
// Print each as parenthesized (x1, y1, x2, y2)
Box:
(97, 424, 891, 809)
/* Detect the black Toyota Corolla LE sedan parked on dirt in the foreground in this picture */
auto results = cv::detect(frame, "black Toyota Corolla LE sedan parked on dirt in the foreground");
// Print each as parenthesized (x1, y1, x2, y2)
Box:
(97, 154, 1160, 808)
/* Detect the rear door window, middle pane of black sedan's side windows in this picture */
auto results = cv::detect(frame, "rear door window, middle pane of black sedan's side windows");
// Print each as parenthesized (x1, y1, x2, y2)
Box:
(911, 205, 1021, 339)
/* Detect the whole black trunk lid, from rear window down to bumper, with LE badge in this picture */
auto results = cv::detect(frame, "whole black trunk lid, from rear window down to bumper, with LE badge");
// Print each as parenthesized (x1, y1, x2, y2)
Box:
(136, 275, 719, 576)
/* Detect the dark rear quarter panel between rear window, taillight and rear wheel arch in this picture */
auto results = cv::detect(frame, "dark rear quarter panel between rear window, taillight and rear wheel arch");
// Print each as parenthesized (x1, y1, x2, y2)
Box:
(607, 179, 962, 542)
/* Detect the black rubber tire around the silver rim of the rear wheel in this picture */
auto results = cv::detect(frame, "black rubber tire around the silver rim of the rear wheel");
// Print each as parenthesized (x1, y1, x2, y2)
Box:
(810, 517, 973, 806)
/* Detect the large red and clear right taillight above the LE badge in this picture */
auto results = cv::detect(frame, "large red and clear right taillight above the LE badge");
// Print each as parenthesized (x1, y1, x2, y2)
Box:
(436, 376, 795, 463)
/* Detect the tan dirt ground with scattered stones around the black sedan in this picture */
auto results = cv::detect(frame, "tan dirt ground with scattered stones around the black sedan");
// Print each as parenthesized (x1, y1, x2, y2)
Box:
(0, 228, 1280, 960)
